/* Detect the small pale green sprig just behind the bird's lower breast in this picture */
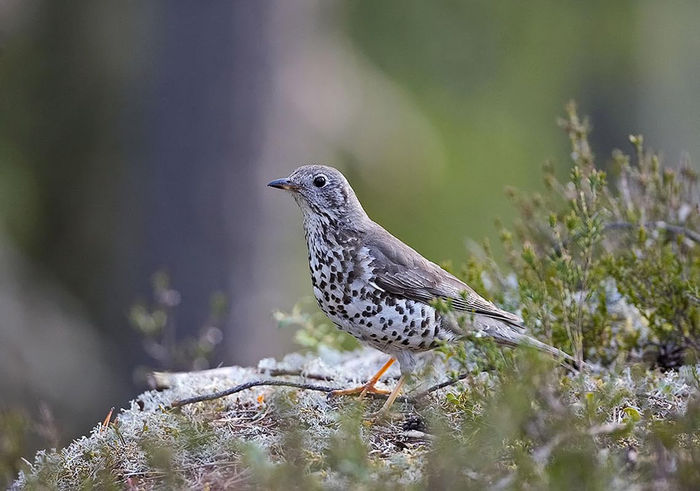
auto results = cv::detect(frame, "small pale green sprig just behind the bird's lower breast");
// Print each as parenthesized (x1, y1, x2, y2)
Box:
(274, 299, 360, 351)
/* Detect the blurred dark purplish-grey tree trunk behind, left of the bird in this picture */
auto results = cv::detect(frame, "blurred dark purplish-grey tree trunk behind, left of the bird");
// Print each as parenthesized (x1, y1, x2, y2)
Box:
(137, 1, 269, 363)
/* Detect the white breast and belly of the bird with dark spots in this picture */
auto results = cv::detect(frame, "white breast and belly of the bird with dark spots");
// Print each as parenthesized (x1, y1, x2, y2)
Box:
(308, 236, 454, 353)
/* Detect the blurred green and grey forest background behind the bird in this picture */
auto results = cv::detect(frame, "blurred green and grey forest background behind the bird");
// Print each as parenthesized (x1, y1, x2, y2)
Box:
(0, 0, 700, 474)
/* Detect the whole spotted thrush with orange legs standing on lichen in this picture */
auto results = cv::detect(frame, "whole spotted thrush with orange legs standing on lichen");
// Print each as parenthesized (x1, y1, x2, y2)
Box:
(268, 164, 577, 414)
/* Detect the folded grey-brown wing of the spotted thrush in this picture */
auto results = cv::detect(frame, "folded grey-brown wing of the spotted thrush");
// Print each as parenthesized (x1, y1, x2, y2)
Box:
(364, 224, 523, 329)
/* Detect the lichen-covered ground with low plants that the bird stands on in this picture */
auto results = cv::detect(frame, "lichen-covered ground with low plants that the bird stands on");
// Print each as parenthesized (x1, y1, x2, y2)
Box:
(13, 350, 700, 489)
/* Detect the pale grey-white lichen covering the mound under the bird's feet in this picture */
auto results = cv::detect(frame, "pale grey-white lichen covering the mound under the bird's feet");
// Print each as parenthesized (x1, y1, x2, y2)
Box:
(14, 349, 454, 489)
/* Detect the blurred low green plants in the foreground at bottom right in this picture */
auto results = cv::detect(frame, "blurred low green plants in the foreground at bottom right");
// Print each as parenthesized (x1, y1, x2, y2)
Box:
(198, 356, 700, 490)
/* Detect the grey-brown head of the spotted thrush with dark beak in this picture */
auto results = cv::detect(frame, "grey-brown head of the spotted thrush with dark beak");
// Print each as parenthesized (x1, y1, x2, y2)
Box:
(268, 165, 365, 220)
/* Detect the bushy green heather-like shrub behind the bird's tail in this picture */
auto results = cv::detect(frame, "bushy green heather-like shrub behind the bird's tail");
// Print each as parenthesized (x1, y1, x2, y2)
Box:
(466, 103, 700, 368)
